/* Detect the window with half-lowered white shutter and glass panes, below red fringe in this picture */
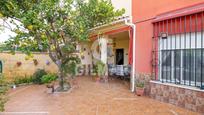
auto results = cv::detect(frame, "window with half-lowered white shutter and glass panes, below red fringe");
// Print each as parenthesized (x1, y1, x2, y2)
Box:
(158, 32, 204, 87)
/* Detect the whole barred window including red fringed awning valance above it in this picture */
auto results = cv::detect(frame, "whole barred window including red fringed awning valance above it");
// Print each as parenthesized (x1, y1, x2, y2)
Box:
(152, 12, 204, 89)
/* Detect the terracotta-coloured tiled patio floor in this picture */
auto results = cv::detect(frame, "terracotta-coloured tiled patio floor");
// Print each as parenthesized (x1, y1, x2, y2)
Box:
(0, 77, 198, 115)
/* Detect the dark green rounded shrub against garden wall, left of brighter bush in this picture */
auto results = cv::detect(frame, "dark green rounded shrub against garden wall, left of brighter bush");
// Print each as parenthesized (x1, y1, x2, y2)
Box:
(33, 69, 47, 84)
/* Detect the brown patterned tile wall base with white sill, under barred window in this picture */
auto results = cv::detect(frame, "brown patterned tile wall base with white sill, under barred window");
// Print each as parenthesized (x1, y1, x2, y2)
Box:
(150, 81, 204, 113)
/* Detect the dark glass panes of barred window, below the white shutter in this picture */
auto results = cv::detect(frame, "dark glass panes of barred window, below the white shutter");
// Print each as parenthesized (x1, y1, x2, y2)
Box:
(160, 49, 204, 86)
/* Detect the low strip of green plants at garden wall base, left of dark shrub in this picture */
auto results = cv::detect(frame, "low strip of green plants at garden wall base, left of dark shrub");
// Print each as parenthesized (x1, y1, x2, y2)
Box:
(13, 76, 33, 85)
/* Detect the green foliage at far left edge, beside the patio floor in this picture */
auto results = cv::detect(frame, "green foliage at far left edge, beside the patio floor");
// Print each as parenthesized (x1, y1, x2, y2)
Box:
(0, 75, 8, 111)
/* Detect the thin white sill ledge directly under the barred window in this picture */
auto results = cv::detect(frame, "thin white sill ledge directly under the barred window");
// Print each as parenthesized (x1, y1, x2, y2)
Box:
(150, 81, 204, 92)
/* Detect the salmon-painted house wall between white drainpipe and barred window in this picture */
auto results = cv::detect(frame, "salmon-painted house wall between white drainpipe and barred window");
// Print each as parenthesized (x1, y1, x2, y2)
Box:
(132, 0, 204, 73)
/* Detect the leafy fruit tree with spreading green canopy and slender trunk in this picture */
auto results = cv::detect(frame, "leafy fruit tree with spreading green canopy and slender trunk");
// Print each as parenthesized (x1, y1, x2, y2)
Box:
(0, 0, 124, 89)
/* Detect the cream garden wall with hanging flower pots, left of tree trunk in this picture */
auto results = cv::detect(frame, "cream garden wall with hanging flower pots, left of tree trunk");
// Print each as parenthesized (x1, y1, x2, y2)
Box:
(0, 52, 58, 80)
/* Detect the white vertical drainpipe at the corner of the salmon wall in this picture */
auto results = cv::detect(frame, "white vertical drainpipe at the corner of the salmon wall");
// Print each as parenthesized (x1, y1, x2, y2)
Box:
(125, 17, 136, 92)
